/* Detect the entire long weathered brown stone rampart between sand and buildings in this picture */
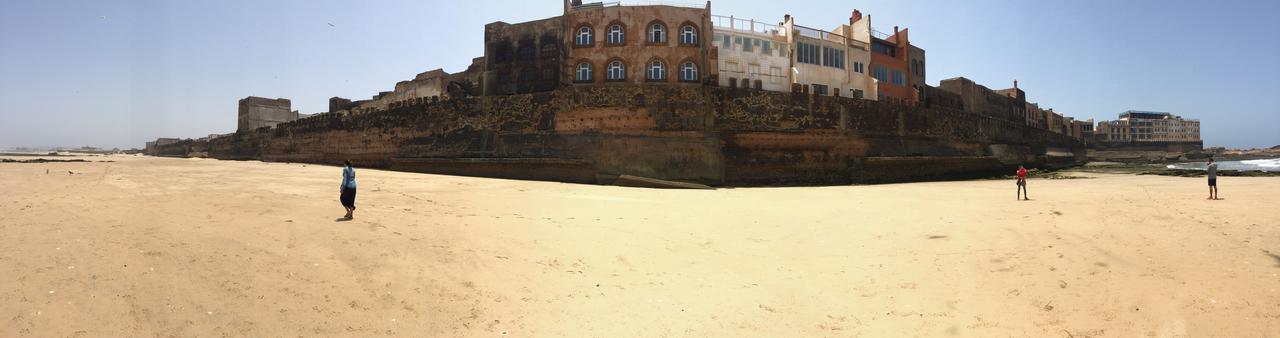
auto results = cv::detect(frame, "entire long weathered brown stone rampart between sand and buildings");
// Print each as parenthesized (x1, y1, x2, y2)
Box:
(161, 86, 1084, 186)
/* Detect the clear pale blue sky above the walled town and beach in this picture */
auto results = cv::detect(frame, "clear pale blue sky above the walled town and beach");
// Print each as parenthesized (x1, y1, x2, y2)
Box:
(0, 0, 1280, 147)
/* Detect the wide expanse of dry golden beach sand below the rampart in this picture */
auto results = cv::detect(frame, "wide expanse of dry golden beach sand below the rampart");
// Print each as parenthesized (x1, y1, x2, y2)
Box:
(0, 156, 1280, 337)
